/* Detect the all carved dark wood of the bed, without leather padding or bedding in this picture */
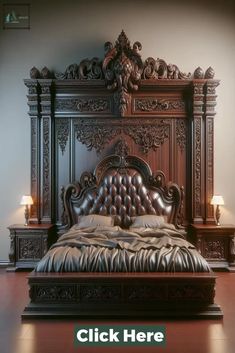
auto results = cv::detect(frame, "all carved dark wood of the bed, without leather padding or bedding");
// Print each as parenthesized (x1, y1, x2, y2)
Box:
(23, 31, 222, 318)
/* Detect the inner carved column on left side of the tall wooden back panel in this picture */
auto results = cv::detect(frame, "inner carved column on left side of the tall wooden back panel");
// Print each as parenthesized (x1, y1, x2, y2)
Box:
(39, 79, 54, 223)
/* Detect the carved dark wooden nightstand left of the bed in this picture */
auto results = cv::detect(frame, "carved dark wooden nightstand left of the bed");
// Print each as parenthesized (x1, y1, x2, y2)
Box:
(7, 224, 56, 271)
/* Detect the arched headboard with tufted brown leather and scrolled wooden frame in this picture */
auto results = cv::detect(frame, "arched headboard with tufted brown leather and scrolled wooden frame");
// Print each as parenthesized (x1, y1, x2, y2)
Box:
(62, 155, 182, 228)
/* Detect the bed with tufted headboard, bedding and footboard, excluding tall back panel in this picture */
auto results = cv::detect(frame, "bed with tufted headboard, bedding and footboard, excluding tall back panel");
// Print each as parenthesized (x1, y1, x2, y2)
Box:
(22, 154, 222, 319)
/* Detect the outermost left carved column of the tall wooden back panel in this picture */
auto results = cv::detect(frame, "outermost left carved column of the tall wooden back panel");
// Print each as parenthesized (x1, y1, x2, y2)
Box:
(24, 79, 40, 223)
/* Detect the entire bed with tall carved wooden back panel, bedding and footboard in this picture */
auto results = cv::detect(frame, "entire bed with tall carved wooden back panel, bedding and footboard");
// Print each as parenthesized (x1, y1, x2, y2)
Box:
(23, 31, 223, 318)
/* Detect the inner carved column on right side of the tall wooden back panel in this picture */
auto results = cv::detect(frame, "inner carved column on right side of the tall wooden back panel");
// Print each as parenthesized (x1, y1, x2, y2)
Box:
(192, 80, 205, 223)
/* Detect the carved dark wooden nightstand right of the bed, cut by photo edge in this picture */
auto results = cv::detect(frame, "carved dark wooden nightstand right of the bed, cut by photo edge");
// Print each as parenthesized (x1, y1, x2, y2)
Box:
(189, 224, 235, 272)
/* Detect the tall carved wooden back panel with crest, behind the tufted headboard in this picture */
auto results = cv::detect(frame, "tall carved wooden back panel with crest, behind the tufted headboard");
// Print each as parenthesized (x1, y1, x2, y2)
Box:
(25, 31, 219, 227)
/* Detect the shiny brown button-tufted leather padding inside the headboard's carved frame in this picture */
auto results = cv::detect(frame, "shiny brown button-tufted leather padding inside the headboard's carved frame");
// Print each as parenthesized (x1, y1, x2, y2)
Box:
(73, 169, 174, 227)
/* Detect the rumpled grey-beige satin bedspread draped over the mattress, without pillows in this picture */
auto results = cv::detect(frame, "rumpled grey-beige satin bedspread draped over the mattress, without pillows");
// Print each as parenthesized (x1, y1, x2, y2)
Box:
(35, 223, 210, 272)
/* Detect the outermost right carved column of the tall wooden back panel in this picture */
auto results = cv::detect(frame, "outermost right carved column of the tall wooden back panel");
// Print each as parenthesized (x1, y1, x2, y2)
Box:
(205, 78, 219, 224)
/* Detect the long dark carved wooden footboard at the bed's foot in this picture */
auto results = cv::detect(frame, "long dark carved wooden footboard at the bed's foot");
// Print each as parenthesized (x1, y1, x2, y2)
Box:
(22, 272, 223, 319)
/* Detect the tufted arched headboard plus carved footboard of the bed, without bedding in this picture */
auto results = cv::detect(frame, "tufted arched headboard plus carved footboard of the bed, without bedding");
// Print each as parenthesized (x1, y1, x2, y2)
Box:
(23, 155, 222, 318)
